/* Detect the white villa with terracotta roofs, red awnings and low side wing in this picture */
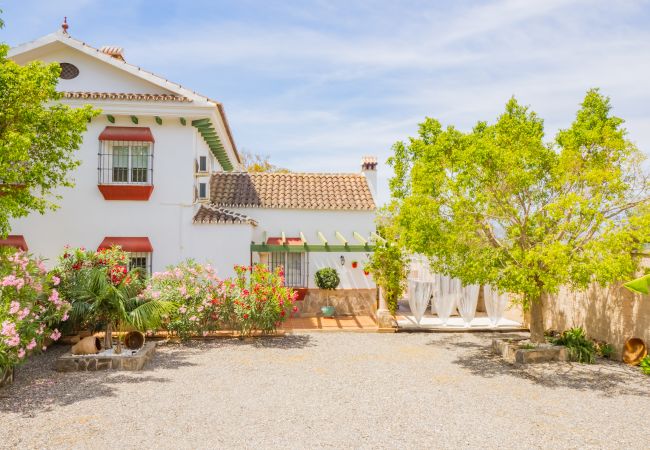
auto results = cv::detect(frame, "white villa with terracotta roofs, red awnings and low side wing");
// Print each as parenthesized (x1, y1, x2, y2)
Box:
(5, 28, 377, 312)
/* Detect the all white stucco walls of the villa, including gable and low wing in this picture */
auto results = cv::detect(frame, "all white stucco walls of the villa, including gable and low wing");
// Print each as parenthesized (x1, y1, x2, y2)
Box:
(6, 37, 375, 288)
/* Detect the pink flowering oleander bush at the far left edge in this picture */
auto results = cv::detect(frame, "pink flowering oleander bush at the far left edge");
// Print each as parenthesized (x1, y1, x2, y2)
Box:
(0, 249, 70, 369)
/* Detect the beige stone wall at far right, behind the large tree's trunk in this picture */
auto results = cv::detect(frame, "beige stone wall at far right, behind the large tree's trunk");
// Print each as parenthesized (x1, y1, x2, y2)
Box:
(544, 284, 650, 359)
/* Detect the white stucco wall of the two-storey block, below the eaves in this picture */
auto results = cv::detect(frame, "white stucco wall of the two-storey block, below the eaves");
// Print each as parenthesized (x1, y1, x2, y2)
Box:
(11, 112, 252, 273)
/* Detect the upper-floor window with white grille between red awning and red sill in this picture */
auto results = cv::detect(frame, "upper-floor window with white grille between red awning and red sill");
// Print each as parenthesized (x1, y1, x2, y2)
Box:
(97, 141, 153, 185)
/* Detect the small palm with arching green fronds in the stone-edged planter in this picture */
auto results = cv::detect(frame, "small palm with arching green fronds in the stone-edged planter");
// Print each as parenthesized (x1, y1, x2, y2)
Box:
(70, 266, 174, 353)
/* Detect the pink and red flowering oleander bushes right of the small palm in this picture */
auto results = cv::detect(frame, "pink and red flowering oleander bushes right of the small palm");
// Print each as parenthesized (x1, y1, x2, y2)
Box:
(141, 261, 297, 340)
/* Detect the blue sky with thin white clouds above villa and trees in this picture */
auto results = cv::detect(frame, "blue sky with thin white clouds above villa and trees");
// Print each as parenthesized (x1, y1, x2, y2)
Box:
(0, 0, 650, 200)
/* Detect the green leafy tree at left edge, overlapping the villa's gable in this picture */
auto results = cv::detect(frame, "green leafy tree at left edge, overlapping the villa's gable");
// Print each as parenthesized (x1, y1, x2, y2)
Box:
(0, 29, 98, 236)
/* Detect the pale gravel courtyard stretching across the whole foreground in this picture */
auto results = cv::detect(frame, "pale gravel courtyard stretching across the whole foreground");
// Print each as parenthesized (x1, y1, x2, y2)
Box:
(0, 333, 650, 449)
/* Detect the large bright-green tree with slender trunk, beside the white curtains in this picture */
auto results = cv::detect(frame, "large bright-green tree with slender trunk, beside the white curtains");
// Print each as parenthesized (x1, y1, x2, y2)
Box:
(389, 89, 650, 342)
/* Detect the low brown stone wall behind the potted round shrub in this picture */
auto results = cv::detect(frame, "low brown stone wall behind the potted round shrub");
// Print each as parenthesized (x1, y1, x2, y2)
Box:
(297, 289, 377, 317)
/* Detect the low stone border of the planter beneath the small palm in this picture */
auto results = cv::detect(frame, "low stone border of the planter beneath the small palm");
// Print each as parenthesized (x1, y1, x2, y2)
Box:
(54, 342, 156, 372)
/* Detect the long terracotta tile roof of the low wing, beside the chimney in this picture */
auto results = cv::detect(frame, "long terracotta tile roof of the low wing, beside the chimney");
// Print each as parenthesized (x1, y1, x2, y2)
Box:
(210, 172, 375, 211)
